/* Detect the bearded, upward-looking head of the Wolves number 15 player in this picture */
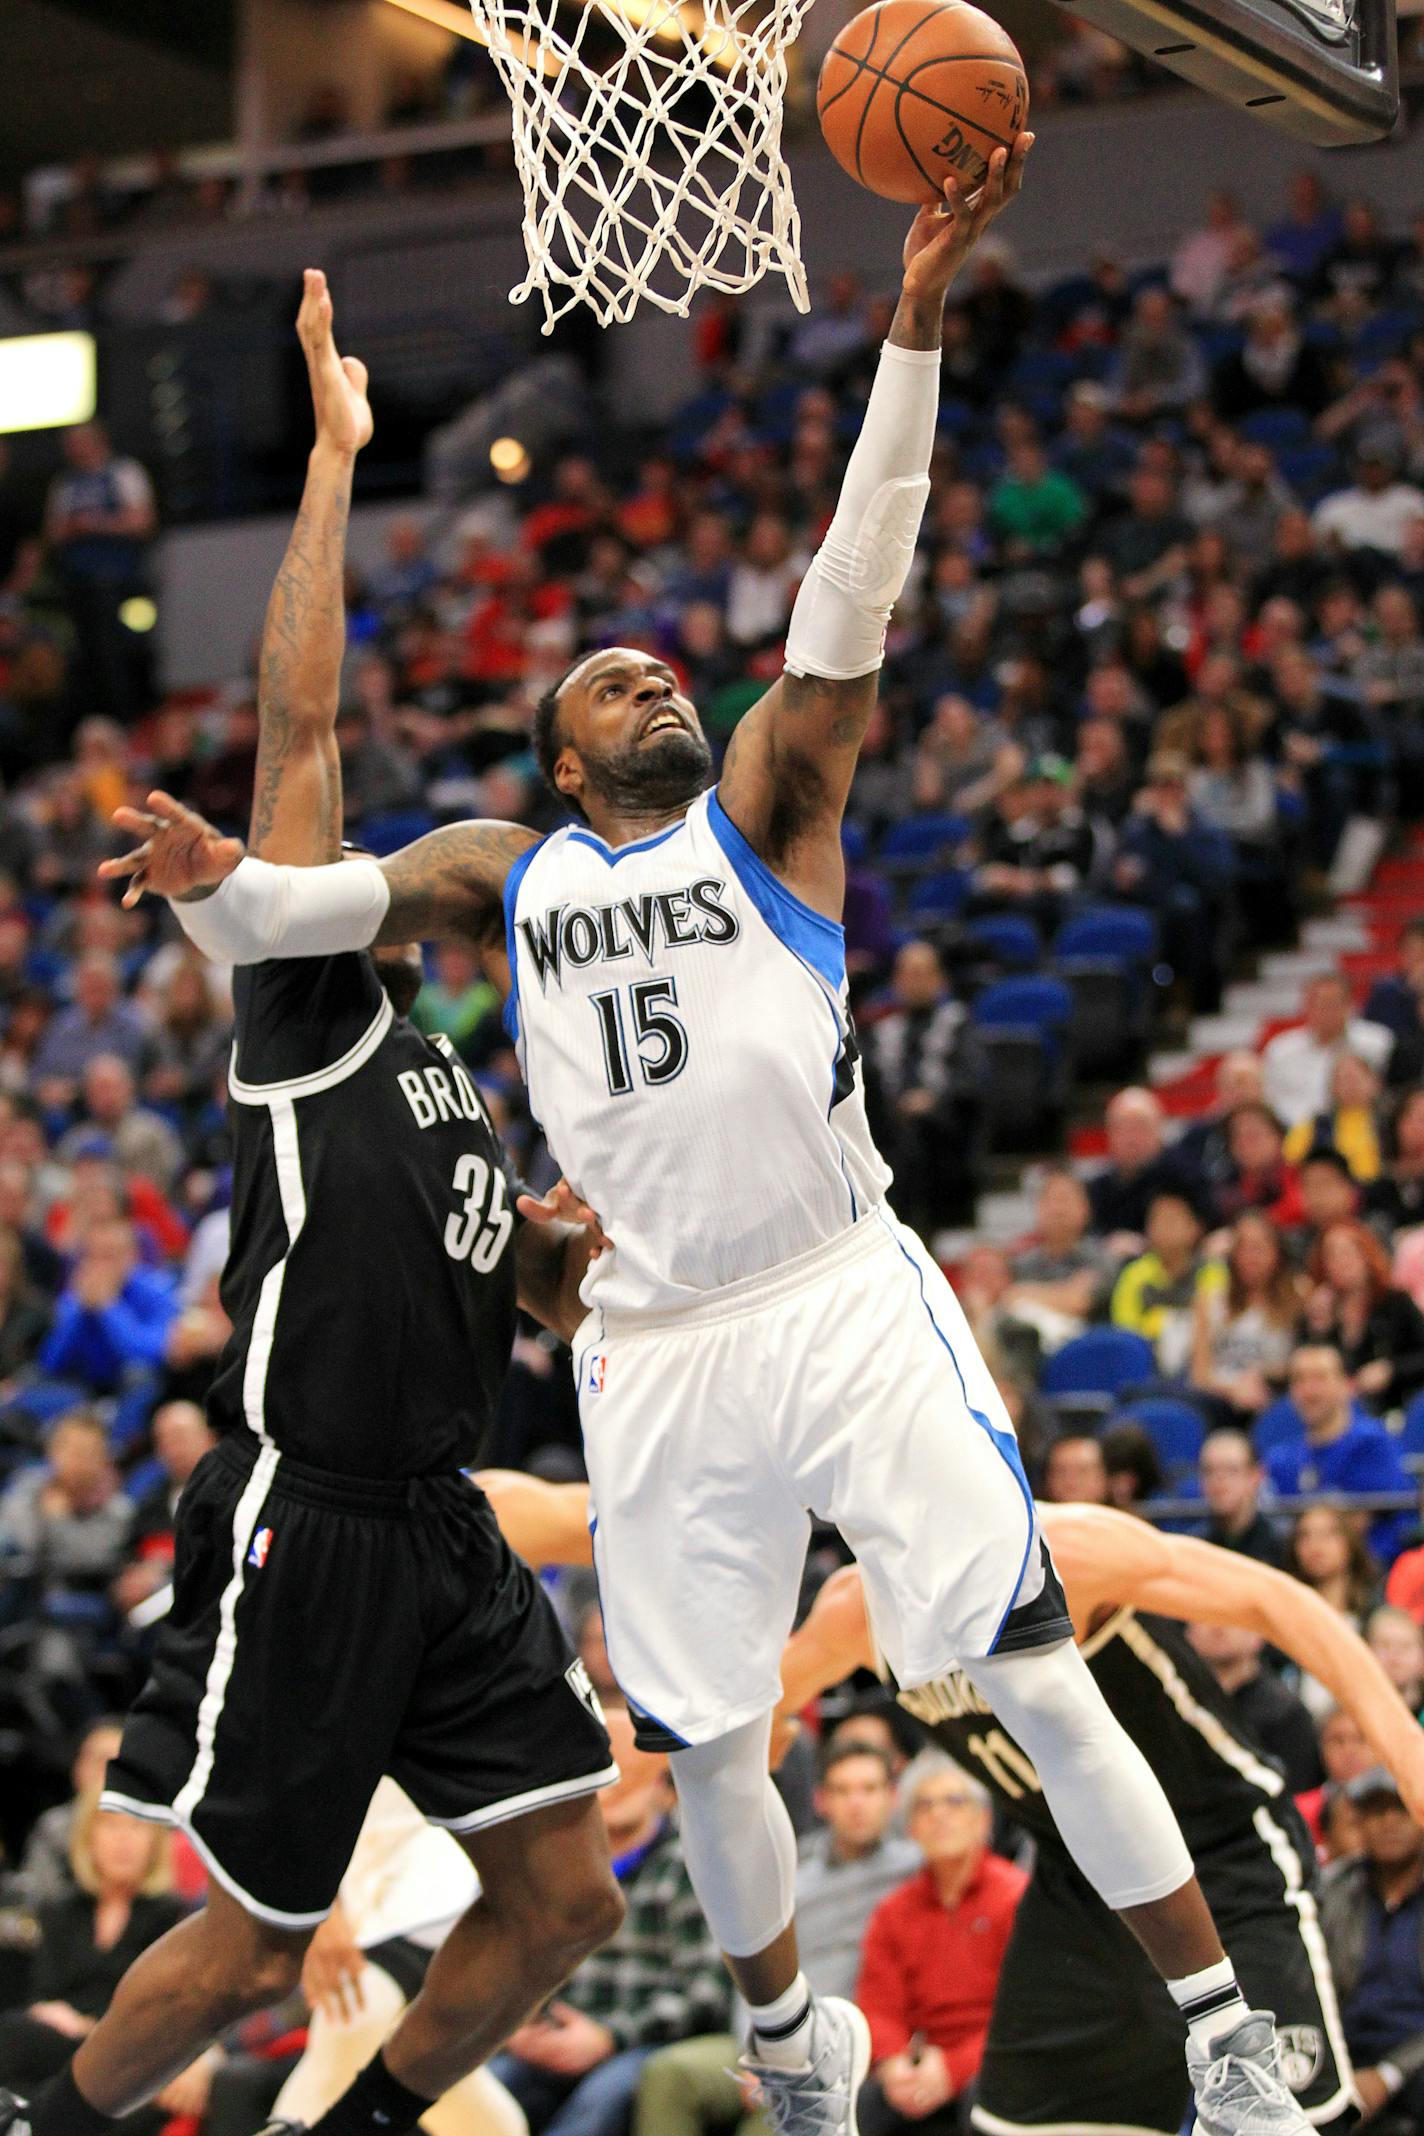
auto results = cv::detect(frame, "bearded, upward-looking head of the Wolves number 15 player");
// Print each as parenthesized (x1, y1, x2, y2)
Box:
(555, 647, 711, 820)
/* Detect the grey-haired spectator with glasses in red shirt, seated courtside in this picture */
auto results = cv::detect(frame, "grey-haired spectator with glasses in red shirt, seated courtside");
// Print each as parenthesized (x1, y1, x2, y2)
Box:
(856, 1749, 1027, 2136)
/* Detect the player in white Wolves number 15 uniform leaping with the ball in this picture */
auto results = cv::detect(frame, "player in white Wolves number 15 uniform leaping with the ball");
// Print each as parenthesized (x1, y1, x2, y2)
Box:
(107, 158, 1304, 2136)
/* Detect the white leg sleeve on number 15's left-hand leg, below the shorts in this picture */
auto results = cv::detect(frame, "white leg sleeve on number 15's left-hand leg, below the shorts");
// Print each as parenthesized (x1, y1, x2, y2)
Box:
(670, 1713, 796, 1959)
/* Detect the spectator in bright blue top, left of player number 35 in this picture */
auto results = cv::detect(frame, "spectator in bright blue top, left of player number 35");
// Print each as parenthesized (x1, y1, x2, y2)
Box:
(38, 1218, 177, 1395)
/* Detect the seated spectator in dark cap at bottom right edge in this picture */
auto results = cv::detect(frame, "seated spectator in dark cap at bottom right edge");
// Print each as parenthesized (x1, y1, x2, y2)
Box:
(1322, 1766, 1424, 2130)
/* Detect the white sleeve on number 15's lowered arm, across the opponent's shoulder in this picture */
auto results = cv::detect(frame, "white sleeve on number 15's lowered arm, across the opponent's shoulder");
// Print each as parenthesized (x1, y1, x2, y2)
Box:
(173, 854, 391, 963)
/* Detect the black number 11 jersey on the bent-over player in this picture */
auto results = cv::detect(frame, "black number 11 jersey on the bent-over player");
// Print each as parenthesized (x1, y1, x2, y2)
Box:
(897, 1608, 1309, 1863)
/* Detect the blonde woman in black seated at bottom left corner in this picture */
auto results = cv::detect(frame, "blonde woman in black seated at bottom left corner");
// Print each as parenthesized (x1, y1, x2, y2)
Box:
(0, 1788, 192, 2130)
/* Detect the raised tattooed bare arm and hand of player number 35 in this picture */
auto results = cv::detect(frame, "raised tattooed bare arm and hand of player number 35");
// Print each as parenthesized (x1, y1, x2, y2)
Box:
(248, 267, 371, 867)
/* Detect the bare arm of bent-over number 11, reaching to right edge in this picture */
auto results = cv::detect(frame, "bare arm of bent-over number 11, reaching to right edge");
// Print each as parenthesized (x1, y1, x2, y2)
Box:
(1042, 1506, 1424, 1818)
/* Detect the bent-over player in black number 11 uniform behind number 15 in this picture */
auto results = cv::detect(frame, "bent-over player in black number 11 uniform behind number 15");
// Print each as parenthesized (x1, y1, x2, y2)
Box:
(485, 1472, 1424, 2136)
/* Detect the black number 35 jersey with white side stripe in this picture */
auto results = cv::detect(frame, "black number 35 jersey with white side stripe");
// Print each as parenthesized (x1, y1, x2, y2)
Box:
(209, 955, 517, 1478)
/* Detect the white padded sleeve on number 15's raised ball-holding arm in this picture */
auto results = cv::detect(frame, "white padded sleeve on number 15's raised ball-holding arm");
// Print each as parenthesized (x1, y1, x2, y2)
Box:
(786, 342, 939, 681)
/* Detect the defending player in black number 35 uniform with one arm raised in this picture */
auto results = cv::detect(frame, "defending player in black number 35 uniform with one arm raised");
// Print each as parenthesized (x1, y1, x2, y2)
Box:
(0, 273, 621, 2136)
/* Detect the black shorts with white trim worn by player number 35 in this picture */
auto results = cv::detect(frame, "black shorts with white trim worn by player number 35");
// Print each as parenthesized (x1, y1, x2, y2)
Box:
(105, 1433, 617, 1929)
